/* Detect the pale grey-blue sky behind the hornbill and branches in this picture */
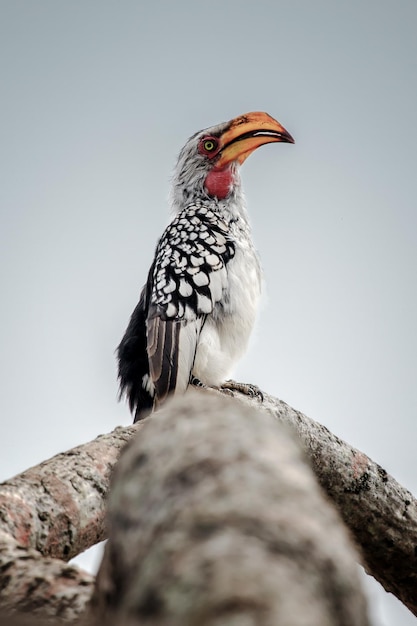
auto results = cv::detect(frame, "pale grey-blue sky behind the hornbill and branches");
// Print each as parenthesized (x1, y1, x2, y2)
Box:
(0, 0, 417, 626)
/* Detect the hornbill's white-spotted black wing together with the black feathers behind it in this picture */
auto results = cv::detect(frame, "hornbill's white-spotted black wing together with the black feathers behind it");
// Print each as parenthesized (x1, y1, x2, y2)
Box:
(117, 203, 235, 421)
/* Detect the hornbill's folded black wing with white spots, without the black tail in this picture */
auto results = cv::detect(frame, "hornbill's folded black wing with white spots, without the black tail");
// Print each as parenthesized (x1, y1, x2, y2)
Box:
(146, 203, 235, 401)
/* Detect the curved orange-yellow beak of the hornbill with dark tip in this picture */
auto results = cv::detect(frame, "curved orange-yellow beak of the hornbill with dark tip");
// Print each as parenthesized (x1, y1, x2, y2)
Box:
(216, 111, 294, 169)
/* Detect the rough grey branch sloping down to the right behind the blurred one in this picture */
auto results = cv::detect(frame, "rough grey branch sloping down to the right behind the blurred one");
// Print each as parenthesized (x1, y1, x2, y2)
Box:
(244, 394, 417, 615)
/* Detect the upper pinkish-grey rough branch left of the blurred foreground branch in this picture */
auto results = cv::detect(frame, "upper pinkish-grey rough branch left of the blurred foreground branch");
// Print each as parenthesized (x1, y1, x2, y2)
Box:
(0, 426, 138, 561)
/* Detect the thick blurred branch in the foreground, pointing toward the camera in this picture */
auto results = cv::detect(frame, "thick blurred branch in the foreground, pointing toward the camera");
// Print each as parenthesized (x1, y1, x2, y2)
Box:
(92, 392, 368, 626)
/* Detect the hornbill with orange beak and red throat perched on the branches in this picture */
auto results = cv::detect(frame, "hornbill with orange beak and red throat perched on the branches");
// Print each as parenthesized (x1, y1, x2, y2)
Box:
(117, 111, 294, 422)
